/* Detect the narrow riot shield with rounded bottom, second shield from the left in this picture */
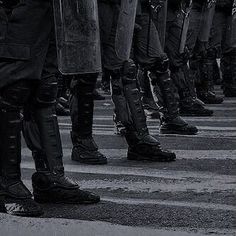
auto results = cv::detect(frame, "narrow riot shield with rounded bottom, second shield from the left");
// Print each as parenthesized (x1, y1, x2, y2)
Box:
(115, 0, 138, 61)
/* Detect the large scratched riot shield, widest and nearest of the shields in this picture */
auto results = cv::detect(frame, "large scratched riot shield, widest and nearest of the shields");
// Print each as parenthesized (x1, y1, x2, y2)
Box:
(54, 0, 102, 75)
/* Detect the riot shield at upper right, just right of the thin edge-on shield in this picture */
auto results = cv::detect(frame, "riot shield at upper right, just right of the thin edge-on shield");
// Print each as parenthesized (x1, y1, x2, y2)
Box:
(198, 0, 216, 42)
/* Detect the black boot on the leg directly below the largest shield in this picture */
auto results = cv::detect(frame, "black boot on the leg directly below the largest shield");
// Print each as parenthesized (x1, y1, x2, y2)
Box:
(71, 132, 107, 165)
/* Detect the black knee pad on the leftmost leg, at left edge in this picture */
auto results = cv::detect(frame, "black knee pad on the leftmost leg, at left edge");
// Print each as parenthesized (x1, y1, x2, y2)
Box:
(0, 80, 32, 109)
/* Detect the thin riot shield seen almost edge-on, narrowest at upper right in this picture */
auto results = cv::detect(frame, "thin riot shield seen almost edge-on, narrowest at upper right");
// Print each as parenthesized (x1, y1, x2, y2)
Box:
(179, 0, 193, 54)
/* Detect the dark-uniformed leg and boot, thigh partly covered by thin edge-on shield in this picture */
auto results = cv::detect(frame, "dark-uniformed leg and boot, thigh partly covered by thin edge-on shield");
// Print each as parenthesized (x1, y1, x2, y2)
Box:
(165, 0, 213, 116)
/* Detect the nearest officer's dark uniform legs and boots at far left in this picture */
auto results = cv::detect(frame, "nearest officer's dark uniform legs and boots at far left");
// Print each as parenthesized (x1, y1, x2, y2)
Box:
(0, 0, 99, 216)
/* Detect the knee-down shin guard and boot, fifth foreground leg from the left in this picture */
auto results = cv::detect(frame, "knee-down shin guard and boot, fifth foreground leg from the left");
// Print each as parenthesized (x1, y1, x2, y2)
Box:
(150, 61, 198, 135)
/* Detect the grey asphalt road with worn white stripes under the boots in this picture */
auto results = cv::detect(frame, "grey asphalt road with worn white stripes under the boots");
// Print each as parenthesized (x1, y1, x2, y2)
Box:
(0, 87, 236, 236)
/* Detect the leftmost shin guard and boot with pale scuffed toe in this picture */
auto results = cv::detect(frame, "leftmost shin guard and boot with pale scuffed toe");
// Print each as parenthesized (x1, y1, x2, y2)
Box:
(0, 109, 43, 217)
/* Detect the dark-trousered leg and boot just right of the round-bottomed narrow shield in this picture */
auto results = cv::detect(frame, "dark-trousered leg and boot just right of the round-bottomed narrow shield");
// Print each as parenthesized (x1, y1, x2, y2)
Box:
(134, 1, 197, 134)
